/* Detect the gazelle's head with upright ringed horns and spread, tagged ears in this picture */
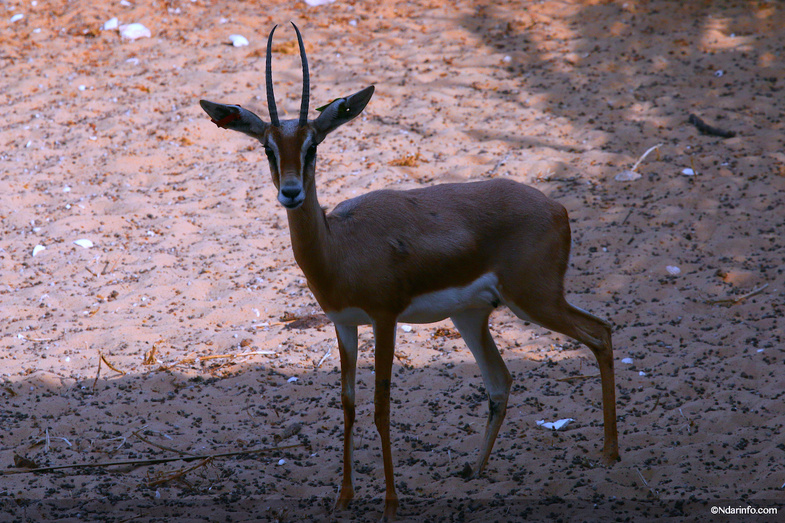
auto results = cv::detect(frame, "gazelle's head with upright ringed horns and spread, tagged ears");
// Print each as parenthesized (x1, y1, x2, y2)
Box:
(199, 22, 374, 209)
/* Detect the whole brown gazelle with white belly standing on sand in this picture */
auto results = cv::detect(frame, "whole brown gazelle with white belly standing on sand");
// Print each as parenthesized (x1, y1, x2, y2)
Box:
(200, 24, 619, 520)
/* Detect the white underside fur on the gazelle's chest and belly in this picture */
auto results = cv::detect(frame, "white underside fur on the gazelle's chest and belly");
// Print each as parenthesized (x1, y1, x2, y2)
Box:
(327, 272, 502, 325)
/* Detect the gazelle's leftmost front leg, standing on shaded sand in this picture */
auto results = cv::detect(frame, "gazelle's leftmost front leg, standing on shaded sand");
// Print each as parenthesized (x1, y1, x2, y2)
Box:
(335, 323, 357, 510)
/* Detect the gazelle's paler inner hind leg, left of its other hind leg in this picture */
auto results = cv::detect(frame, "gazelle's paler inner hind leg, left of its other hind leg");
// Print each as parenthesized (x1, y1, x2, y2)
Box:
(450, 309, 512, 476)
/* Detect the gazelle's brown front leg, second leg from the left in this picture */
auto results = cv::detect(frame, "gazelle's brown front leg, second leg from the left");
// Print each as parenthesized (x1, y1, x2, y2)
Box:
(373, 318, 398, 521)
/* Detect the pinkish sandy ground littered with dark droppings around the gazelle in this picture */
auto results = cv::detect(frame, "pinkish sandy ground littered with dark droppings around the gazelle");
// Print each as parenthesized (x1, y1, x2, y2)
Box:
(0, 0, 785, 521)
